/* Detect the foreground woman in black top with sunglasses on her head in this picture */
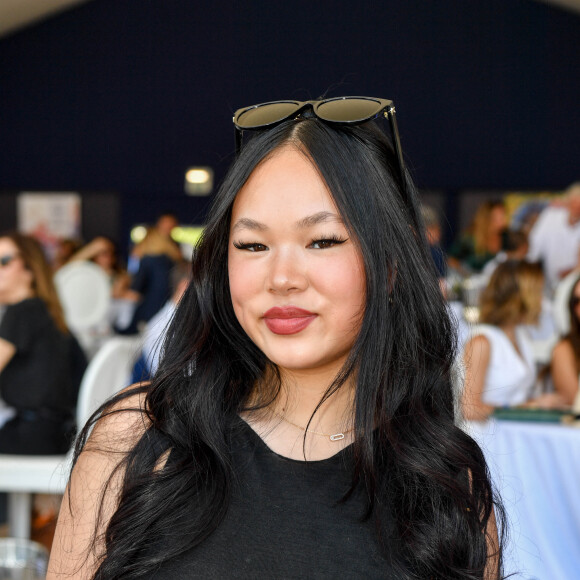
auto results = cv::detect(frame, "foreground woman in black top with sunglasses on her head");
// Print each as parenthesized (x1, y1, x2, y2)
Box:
(48, 97, 505, 579)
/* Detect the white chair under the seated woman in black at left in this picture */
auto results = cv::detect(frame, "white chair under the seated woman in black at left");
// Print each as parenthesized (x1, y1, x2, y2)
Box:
(0, 337, 142, 538)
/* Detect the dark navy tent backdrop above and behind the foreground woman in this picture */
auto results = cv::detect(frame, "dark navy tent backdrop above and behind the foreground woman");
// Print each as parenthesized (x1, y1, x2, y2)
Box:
(0, 0, 580, 230)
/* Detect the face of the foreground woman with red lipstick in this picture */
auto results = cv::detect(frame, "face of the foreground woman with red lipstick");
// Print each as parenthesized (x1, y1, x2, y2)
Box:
(228, 147, 365, 374)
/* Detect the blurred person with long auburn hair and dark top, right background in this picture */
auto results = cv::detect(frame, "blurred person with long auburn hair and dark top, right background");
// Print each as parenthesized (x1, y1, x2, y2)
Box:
(447, 200, 508, 273)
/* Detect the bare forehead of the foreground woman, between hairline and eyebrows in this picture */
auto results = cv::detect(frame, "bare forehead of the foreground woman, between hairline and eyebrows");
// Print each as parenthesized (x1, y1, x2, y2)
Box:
(232, 147, 338, 223)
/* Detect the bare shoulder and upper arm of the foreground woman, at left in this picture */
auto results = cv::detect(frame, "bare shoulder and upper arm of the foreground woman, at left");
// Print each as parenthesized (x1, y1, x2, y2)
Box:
(47, 385, 150, 580)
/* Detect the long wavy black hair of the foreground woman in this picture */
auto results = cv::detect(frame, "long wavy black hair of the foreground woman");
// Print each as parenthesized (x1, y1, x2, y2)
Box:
(77, 118, 503, 579)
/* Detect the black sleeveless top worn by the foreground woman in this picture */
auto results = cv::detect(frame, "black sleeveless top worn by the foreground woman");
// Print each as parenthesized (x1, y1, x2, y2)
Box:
(147, 420, 395, 580)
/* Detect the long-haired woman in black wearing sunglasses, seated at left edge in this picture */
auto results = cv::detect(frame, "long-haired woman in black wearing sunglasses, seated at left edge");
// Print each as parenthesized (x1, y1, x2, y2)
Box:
(0, 233, 86, 455)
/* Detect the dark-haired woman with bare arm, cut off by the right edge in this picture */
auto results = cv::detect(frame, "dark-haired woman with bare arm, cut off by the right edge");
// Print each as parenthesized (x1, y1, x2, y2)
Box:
(551, 277, 580, 405)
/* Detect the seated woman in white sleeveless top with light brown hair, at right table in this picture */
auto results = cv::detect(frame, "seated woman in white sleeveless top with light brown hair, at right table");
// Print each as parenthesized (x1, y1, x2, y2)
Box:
(461, 260, 563, 421)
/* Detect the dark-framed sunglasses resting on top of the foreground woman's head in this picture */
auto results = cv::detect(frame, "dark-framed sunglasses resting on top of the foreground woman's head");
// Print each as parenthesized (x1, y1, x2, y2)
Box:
(234, 97, 406, 194)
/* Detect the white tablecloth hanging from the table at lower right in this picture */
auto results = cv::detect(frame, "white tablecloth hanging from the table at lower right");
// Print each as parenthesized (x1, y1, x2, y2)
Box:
(466, 419, 580, 580)
